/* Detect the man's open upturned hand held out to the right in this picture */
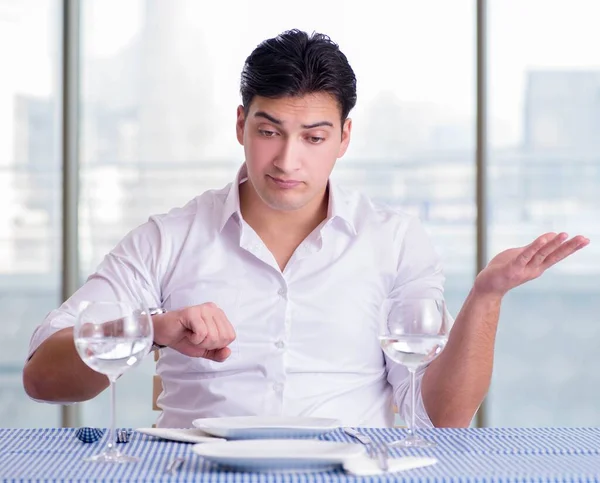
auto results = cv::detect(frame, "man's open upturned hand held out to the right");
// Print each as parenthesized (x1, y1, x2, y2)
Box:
(475, 233, 590, 295)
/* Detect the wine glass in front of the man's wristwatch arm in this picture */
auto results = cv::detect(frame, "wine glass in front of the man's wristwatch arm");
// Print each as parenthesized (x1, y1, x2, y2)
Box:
(73, 302, 154, 463)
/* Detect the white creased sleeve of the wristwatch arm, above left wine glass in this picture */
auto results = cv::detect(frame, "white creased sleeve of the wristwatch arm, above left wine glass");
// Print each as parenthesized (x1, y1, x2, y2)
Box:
(27, 218, 162, 359)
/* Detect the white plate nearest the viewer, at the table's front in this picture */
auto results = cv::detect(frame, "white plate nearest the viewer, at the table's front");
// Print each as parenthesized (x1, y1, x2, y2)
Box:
(192, 439, 365, 472)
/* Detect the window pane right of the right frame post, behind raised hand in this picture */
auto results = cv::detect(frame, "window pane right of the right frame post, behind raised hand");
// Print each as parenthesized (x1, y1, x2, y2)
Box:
(488, 0, 600, 426)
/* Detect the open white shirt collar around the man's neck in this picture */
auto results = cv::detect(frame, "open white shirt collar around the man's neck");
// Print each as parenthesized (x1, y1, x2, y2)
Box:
(219, 163, 357, 235)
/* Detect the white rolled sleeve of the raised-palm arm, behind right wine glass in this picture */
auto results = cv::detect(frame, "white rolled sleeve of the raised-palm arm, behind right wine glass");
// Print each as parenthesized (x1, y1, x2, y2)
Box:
(385, 218, 445, 428)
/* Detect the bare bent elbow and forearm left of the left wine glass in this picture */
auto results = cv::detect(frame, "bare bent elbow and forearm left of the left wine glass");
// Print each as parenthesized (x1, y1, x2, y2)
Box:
(23, 327, 108, 402)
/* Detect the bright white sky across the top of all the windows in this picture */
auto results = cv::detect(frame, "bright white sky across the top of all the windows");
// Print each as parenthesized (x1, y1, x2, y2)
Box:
(0, 0, 600, 161)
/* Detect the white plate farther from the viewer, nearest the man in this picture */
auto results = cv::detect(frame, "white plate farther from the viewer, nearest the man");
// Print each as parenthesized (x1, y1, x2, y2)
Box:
(192, 416, 341, 439)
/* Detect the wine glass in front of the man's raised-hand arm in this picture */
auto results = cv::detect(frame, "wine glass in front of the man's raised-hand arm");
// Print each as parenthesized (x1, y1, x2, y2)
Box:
(379, 298, 451, 448)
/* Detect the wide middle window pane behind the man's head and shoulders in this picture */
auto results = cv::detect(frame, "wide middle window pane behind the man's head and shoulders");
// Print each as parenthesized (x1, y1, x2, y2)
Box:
(81, 0, 475, 425)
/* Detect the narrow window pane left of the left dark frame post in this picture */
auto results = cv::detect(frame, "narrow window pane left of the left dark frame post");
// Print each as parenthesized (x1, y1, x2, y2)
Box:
(0, 0, 61, 427)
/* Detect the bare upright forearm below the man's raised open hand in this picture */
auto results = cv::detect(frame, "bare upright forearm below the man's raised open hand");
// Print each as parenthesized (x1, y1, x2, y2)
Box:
(421, 289, 501, 427)
